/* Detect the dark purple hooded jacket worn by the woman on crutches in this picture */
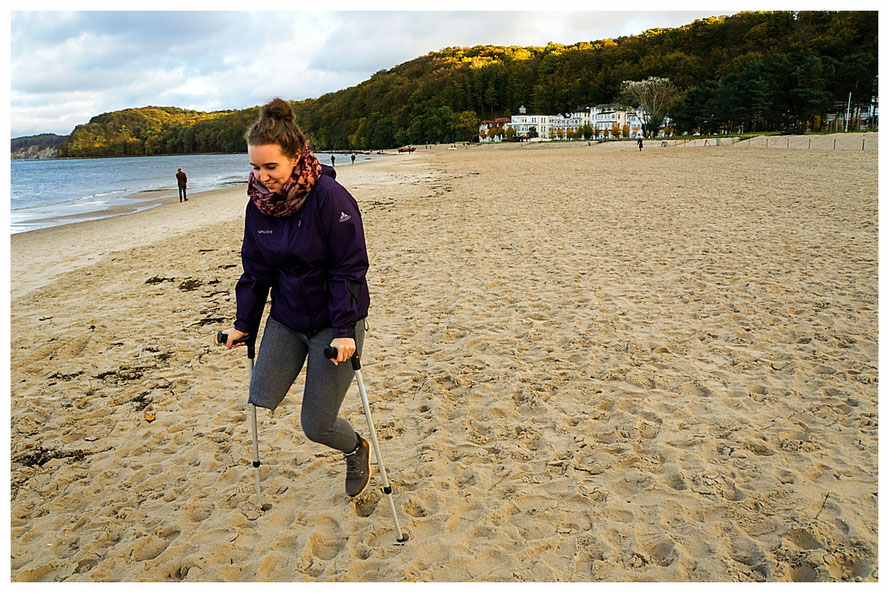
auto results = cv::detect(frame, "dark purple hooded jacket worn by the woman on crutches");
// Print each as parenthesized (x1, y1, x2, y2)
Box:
(234, 165, 370, 338)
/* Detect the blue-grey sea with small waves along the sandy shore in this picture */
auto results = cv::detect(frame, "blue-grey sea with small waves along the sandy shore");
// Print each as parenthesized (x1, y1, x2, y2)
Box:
(9, 152, 377, 235)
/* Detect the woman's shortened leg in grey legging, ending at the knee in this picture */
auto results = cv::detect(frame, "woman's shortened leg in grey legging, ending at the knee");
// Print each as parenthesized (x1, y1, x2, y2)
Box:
(248, 317, 308, 410)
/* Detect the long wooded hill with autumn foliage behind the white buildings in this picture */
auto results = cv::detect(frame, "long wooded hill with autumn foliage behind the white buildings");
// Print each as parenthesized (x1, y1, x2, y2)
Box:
(59, 11, 878, 156)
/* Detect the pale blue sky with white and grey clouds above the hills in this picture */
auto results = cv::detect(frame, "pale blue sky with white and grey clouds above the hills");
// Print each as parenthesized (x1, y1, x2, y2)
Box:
(9, 0, 733, 137)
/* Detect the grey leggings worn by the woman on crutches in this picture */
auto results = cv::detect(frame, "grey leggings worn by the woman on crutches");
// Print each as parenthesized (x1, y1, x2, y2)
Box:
(248, 317, 364, 453)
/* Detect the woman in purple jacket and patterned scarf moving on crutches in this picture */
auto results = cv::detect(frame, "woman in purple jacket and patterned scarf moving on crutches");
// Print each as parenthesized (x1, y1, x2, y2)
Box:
(224, 98, 370, 496)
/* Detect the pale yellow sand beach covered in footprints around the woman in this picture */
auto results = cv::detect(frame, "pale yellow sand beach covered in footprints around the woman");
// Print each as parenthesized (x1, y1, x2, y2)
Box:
(10, 134, 878, 582)
